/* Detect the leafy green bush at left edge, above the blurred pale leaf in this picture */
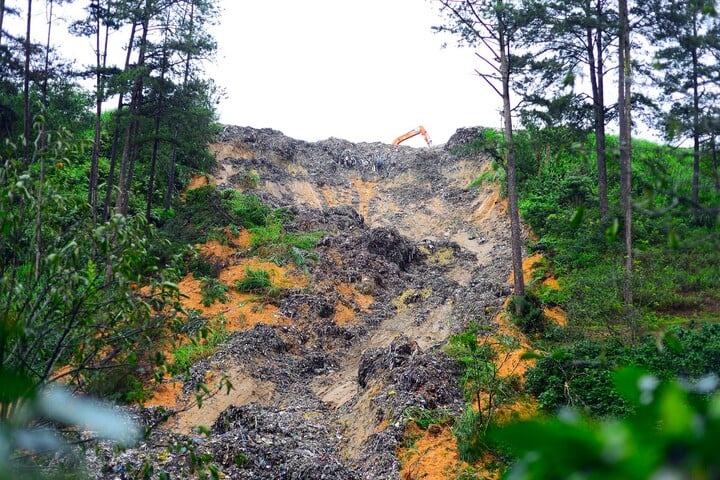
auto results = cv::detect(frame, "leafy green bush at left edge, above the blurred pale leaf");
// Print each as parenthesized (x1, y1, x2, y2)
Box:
(0, 140, 184, 408)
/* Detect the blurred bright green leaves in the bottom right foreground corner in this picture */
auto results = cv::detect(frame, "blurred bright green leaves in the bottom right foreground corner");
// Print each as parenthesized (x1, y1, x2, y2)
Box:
(490, 370, 720, 480)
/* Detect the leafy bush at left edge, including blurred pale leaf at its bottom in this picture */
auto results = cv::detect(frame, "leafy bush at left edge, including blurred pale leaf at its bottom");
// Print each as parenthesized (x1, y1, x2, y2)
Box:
(0, 138, 180, 478)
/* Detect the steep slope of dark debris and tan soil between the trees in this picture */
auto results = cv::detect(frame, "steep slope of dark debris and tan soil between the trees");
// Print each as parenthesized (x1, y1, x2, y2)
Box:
(97, 127, 510, 479)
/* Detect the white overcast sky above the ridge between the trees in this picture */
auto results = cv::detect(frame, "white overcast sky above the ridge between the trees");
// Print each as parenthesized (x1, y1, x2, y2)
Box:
(208, 0, 500, 146)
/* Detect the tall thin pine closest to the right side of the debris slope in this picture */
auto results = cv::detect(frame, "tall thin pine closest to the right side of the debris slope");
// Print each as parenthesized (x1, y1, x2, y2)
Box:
(436, 0, 525, 314)
